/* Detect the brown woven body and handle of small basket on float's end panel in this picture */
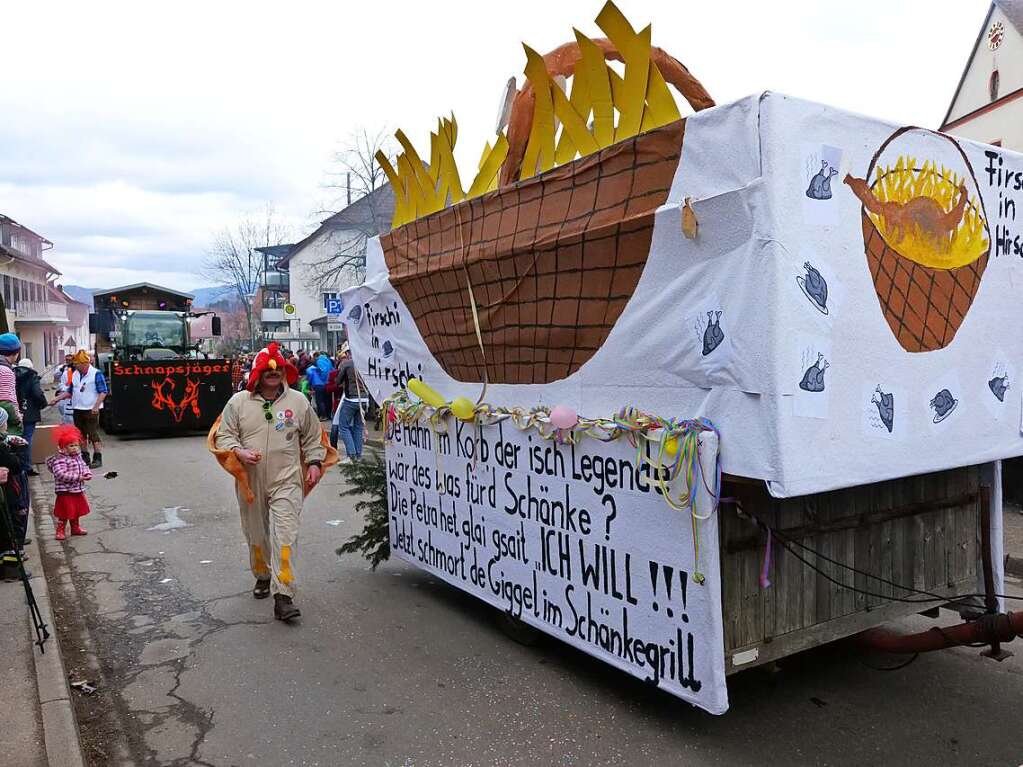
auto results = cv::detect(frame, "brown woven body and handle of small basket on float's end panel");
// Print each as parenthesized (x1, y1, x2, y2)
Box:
(861, 128, 990, 352)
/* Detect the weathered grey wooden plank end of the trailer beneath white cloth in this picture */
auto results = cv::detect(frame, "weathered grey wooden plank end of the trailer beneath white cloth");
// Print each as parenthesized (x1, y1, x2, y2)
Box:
(720, 466, 981, 674)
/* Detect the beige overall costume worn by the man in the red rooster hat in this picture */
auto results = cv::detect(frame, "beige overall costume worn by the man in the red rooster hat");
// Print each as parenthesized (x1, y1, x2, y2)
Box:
(216, 386, 326, 596)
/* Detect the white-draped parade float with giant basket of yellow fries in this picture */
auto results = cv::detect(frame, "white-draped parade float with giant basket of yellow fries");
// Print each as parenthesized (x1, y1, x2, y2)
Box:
(344, 3, 1023, 714)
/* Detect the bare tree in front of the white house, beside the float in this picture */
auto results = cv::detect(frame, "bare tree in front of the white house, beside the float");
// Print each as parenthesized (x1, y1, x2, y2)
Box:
(306, 129, 397, 290)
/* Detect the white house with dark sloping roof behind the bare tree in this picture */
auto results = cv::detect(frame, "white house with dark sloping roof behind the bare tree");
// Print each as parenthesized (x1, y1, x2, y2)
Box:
(272, 184, 394, 351)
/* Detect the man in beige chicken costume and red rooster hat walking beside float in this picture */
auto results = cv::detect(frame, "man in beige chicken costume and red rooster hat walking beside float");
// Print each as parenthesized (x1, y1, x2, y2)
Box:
(209, 344, 338, 621)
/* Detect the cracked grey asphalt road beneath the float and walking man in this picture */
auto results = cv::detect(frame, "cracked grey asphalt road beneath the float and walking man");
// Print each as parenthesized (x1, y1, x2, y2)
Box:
(41, 438, 1023, 767)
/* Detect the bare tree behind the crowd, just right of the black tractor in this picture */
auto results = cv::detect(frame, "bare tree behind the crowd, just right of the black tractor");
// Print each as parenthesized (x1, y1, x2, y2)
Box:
(199, 205, 290, 349)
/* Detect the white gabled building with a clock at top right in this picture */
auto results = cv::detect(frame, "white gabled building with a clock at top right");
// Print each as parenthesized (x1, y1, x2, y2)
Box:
(940, 0, 1023, 146)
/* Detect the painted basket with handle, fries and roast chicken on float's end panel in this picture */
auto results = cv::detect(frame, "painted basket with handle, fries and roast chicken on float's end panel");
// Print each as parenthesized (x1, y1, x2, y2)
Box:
(845, 128, 990, 352)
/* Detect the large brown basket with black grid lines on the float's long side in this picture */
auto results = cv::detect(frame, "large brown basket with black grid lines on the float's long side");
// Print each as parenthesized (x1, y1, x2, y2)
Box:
(381, 120, 685, 384)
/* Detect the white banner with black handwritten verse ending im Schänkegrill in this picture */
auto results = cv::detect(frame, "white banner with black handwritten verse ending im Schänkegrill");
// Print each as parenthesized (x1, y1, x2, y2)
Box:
(387, 416, 728, 714)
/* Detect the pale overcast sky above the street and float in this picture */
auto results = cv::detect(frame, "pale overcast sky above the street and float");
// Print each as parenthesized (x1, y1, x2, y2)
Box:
(0, 0, 988, 289)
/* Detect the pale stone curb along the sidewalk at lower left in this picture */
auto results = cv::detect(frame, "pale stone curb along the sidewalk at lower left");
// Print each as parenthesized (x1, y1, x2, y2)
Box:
(28, 501, 85, 767)
